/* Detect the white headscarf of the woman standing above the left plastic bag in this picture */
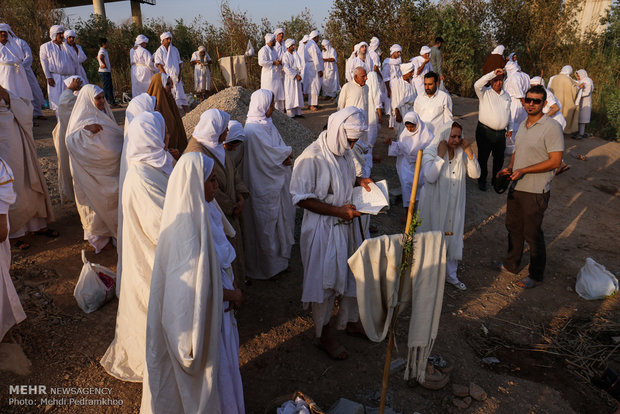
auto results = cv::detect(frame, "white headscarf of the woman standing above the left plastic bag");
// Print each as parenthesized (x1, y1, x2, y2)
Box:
(66, 84, 123, 137)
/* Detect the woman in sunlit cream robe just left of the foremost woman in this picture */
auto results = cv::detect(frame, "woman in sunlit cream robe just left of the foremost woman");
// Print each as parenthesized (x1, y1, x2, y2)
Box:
(101, 109, 173, 382)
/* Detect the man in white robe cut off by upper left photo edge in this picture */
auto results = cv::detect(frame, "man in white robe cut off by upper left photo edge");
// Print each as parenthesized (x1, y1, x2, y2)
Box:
(0, 23, 32, 101)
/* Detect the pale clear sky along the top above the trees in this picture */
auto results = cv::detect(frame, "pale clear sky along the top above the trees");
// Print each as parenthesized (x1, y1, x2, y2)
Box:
(65, 0, 332, 27)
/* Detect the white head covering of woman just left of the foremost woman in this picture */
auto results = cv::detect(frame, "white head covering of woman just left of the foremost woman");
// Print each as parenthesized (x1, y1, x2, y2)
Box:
(126, 111, 173, 175)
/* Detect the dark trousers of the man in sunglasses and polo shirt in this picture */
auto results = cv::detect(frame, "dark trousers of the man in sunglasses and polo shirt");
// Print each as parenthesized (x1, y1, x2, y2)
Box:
(504, 190, 550, 282)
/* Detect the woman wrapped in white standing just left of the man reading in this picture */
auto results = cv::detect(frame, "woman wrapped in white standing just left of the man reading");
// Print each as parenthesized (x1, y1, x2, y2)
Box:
(243, 89, 295, 279)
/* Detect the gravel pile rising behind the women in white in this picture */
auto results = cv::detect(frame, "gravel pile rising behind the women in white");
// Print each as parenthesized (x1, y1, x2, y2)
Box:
(183, 86, 317, 155)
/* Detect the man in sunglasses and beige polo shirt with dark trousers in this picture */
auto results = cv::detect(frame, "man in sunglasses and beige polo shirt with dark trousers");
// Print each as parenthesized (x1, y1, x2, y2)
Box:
(497, 85, 564, 288)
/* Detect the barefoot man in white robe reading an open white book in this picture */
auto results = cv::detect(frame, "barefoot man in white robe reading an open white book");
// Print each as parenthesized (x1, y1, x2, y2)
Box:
(290, 107, 366, 359)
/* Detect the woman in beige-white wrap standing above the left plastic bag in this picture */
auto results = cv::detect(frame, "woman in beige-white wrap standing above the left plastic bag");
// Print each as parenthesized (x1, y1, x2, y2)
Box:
(66, 85, 123, 253)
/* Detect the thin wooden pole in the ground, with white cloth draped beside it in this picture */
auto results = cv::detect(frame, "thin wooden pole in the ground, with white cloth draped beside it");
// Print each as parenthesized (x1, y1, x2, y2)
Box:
(379, 150, 422, 414)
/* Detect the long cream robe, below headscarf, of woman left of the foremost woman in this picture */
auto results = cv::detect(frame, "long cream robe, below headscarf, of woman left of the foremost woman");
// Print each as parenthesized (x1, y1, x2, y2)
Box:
(101, 161, 168, 382)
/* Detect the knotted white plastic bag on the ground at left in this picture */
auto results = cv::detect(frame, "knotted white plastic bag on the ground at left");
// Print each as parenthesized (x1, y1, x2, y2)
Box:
(73, 250, 116, 313)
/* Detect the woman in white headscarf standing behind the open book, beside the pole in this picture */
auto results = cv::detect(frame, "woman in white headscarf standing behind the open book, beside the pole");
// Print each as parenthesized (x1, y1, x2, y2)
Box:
(385, 111, 435, 207)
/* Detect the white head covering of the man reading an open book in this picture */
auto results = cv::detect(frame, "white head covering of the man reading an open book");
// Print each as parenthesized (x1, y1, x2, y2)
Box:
(325, 106, 368, 157)
